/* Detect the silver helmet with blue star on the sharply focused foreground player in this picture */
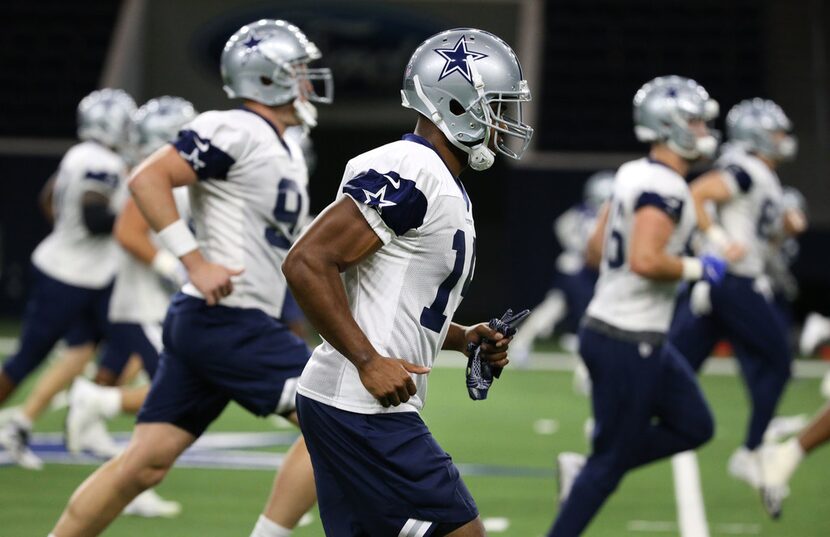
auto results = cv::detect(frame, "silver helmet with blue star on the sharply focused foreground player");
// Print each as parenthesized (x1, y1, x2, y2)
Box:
(401, 28, 533, 170)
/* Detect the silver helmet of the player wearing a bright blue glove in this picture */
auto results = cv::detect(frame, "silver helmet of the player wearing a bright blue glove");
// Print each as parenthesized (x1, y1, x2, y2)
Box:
(634, 75, 720, 160)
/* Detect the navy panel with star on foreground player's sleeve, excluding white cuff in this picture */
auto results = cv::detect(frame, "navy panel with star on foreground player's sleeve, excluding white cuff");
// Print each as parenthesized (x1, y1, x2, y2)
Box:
(343, 169, 427, 236)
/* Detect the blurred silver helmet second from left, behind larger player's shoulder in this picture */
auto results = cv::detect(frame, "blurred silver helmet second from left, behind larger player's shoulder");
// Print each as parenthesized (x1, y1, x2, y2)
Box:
(133, 95, 196, 159)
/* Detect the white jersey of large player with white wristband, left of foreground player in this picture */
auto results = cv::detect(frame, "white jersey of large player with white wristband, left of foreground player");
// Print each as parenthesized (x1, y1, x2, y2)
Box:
(174, 108, 308, 318)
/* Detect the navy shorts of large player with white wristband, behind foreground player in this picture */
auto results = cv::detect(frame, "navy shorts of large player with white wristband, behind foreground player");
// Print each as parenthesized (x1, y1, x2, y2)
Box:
(138, 293, 311, 436)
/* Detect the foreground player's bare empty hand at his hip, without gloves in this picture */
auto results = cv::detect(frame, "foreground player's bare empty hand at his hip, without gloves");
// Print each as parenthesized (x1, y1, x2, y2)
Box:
(358, 355, 430, 407)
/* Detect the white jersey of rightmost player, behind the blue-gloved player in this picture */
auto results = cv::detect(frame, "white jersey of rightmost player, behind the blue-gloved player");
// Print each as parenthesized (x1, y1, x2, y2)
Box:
(716, 149, 783, 278)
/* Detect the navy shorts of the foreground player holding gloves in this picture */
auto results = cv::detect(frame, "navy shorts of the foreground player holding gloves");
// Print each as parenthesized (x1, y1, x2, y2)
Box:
(297, 395, 478, 537)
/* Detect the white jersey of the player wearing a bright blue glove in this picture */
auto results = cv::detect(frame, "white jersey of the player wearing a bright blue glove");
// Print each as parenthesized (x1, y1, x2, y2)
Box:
(587, 158, 697, 334)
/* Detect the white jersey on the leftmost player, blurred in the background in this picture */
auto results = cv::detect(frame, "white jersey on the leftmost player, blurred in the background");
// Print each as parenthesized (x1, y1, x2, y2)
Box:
(32, 142, 127, 289)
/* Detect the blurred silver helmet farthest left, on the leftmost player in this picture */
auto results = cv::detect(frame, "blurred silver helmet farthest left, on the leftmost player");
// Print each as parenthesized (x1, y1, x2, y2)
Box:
(78, 88, 135, 150)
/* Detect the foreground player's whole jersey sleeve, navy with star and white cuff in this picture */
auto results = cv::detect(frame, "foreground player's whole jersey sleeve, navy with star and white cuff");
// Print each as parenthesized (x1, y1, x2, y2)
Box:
(340, 167, 428, 244)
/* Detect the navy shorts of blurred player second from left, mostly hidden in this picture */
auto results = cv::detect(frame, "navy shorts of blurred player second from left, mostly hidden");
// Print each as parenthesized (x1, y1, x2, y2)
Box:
(99, 323, 161, 378)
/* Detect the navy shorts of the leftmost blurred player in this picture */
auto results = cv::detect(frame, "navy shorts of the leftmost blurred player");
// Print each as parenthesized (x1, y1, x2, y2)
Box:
(3, 268, 112, 384)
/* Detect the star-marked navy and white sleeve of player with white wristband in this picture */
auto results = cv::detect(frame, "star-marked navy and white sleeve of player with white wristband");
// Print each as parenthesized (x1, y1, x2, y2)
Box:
(173, 112, 247, 180)
